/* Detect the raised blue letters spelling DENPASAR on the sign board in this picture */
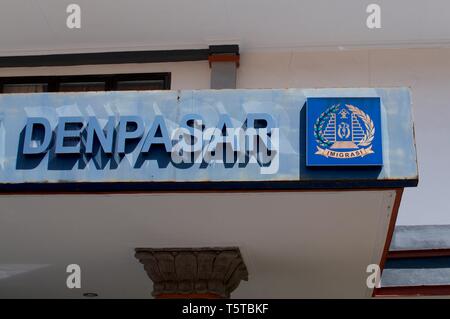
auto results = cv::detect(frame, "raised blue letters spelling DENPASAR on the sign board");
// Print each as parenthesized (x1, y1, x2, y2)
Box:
(22, 113, 279, 174)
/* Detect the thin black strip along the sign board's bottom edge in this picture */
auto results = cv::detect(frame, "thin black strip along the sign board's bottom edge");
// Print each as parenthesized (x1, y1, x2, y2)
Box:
(0, 179, 418, 194)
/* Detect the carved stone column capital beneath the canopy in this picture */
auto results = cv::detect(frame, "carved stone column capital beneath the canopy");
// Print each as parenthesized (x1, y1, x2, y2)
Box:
(135, 247, 248, 298)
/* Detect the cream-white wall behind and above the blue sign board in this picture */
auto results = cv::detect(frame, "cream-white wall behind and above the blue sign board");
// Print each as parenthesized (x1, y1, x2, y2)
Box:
(0, 48, 450, 224)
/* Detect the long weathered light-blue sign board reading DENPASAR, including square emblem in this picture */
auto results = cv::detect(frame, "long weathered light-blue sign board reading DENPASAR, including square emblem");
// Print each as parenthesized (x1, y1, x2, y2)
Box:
(0, 88, 418, 190)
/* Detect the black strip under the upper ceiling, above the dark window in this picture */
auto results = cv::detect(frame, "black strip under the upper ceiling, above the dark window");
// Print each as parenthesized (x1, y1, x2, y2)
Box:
(0, 44, 239, 68)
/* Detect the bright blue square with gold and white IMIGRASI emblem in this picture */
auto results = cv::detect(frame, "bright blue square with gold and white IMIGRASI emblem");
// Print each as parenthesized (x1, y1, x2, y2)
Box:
(306, 97, 383, 166)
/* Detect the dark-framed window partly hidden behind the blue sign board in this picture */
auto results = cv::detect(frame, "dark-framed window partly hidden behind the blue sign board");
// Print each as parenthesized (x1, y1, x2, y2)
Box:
(0, 73, 170, 93)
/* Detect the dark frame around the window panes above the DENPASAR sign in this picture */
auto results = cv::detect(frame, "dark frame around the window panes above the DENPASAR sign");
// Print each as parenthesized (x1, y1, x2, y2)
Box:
(0, 72, 171, 93)
